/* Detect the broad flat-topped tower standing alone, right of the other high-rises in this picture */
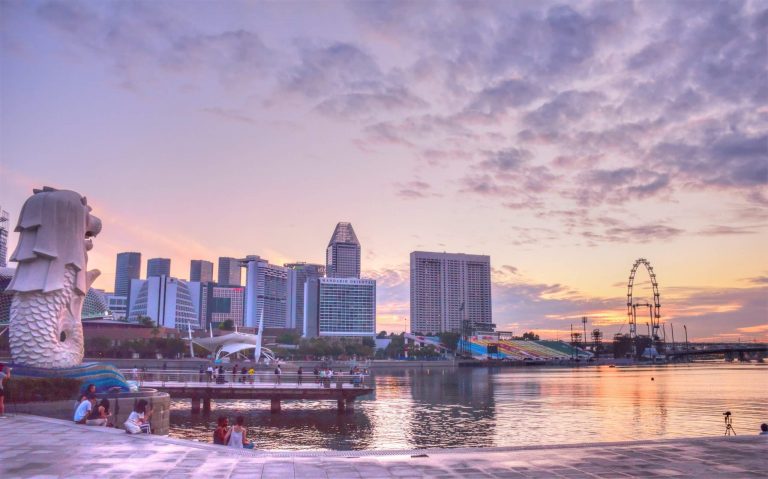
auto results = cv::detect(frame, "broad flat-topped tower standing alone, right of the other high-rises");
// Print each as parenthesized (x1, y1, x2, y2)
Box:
(411, 251, 492, 333)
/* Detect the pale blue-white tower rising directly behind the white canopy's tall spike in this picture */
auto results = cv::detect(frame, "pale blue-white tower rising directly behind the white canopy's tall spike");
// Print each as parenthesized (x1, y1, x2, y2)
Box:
(245, 256, 295, 328)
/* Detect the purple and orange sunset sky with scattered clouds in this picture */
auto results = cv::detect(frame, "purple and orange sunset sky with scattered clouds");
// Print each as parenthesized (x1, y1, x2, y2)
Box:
(0, 0, 768, 341)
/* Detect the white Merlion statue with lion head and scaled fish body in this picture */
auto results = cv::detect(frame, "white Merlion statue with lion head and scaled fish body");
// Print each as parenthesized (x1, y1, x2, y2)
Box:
(8, 187, 101, 368)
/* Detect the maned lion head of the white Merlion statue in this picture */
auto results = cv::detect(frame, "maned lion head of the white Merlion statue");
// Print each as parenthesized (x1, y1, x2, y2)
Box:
(8, 187, 101, 295)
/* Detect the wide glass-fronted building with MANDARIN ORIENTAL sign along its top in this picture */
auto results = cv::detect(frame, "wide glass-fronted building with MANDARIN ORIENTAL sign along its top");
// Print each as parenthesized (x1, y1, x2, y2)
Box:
(304, 278, 376, 338)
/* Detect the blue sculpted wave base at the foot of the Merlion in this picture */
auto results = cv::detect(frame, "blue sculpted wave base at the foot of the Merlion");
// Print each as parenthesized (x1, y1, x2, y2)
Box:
(8, 363, 130, 393)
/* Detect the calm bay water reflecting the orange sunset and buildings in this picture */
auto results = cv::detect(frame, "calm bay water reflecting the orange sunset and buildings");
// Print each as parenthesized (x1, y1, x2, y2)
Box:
(171, 363, 768, 450)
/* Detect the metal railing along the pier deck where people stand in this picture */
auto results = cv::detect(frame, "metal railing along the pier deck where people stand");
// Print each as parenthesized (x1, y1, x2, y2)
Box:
(120, 369, 373, 389)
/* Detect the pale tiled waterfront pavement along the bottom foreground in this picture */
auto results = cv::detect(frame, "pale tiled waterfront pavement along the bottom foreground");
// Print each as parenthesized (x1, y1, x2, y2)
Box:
(0, 415, 768, 479)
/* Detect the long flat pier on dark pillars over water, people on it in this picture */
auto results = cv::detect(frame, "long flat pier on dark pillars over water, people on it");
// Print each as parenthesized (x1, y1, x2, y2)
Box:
(122, 370, 375, 413)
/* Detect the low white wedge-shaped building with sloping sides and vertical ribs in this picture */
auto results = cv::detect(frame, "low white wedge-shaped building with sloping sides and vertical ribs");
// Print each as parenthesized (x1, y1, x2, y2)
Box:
(128, 275, 201, 331)
